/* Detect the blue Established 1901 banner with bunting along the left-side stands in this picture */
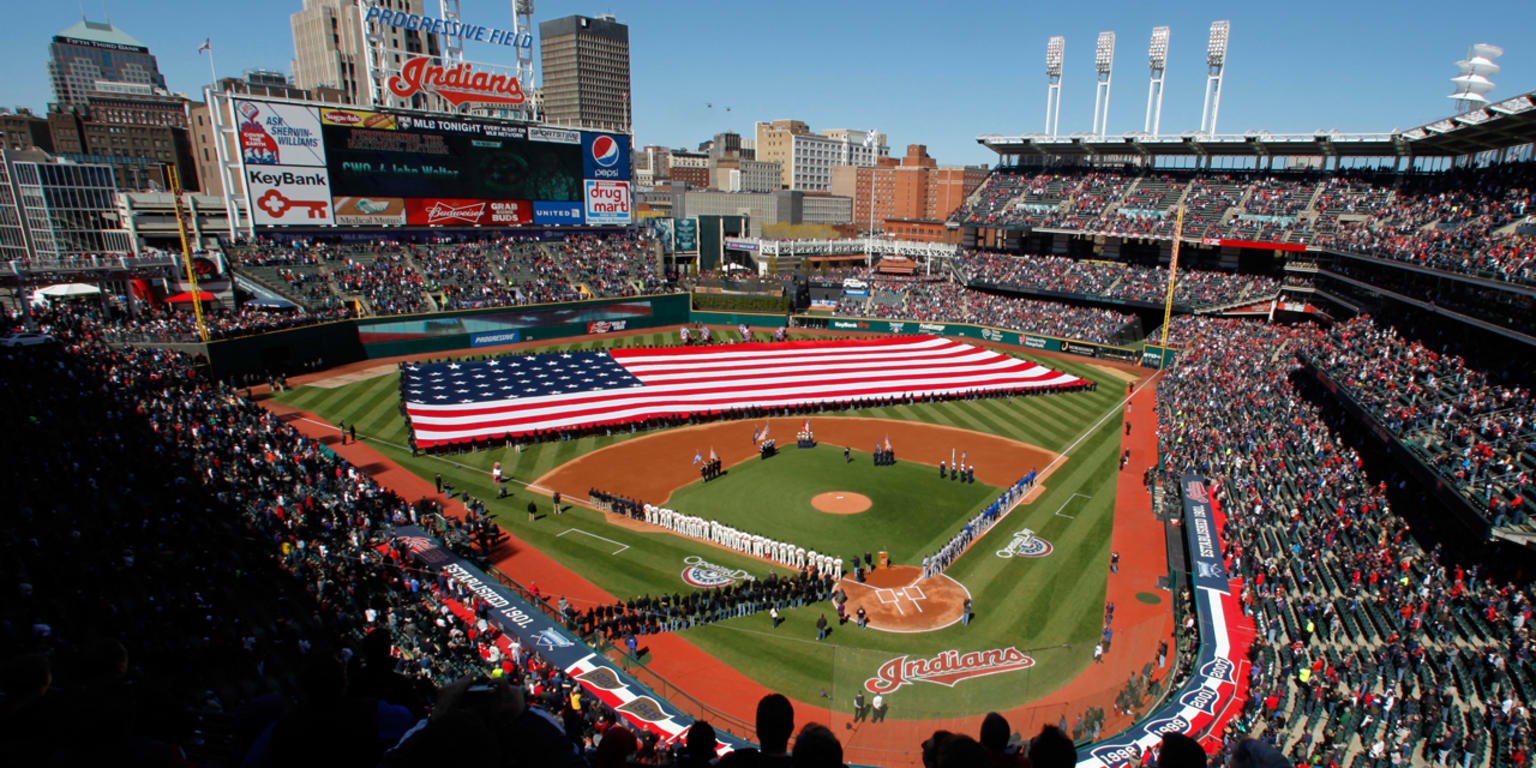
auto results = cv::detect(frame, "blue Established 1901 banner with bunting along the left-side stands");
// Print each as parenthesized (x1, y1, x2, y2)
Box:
(390, 525, 746, 754)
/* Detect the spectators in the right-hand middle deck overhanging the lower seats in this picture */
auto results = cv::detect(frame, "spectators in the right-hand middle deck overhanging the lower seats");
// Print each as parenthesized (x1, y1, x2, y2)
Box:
(1309, 315, 1536, 525)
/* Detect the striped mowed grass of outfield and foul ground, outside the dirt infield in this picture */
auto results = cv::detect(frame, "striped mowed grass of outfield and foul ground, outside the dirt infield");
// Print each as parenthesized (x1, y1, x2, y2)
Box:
(278, 333, 1126, 719)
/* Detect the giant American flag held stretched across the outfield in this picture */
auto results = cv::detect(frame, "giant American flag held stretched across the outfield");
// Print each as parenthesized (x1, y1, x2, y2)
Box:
(401, 336, 1083, 449)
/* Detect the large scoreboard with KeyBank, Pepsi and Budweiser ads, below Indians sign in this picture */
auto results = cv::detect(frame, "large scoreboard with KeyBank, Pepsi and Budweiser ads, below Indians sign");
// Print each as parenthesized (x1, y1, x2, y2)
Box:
(230, 98, 633, 227)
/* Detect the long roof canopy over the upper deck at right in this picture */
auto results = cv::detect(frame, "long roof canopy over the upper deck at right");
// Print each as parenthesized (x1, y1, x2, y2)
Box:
(975, 91, 1536, 160)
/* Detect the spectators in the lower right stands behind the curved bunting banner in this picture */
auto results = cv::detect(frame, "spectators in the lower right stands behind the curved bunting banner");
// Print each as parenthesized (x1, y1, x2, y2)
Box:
(1158, 316, 1536, 768)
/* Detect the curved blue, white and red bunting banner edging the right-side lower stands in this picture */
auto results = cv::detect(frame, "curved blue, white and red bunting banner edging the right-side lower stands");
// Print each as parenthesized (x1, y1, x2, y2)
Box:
(1077, 475, 1253, 768)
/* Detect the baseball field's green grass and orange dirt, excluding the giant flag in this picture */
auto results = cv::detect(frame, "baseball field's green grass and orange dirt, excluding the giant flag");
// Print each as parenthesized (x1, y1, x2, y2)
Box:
(275, 332, 1135, 736)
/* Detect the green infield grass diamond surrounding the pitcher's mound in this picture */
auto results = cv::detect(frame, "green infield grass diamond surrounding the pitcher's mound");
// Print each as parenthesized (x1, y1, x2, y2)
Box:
(667, 445, 1001, 571)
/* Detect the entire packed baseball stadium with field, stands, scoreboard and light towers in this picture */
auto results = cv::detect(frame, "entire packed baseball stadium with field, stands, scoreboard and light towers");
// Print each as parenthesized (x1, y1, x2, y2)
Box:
(0, 3, 1536, 768)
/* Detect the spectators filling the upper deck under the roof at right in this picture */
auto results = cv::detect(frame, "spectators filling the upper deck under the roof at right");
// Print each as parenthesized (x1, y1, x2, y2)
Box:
(951, 161, 1536, 283)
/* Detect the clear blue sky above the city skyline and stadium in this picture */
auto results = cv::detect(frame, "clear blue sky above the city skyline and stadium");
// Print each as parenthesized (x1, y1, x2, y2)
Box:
(0, 0, 1536, 163)
